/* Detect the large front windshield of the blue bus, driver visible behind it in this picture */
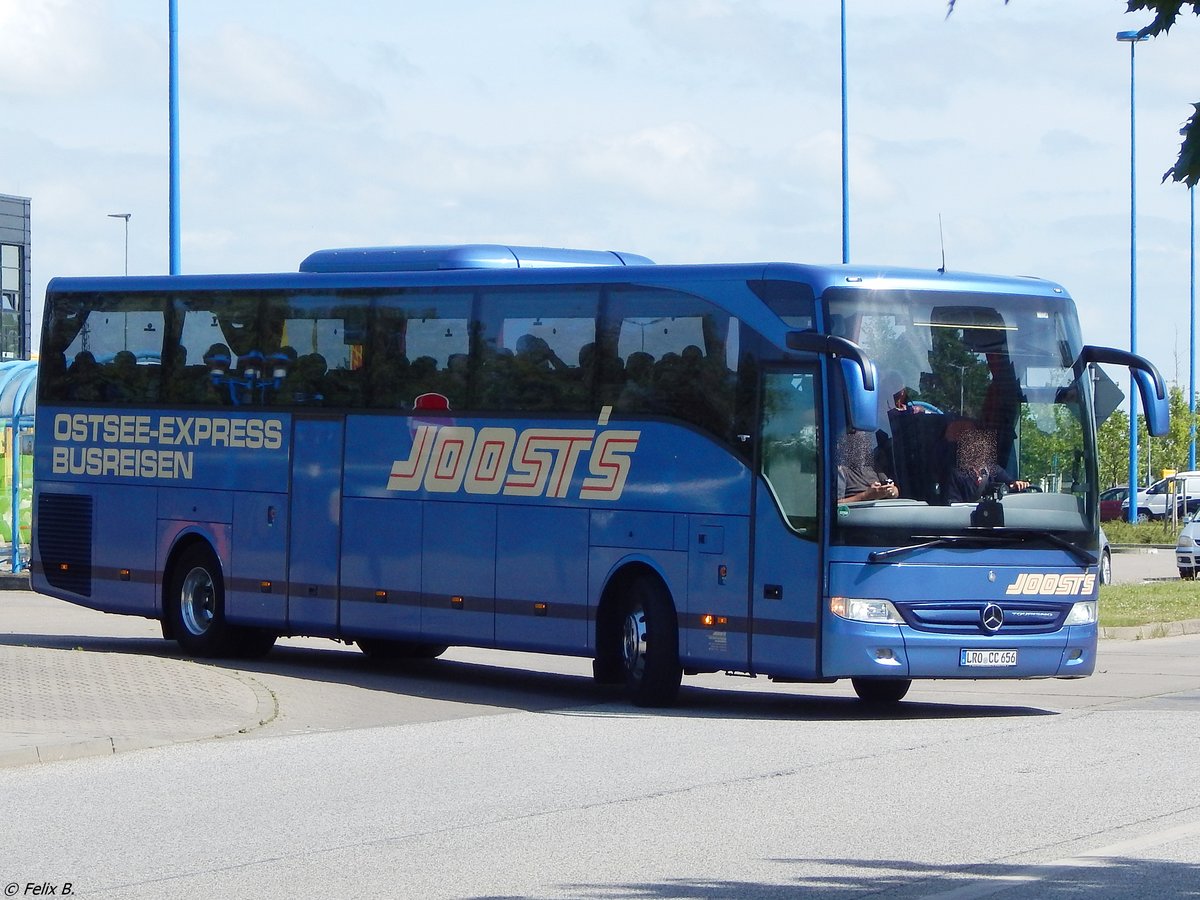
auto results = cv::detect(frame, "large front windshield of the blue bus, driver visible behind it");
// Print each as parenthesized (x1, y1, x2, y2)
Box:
(827, 290, 1096, 547)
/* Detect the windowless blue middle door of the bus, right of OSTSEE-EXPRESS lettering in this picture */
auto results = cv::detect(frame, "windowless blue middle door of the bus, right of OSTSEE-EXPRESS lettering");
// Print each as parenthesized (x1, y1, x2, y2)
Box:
(288, 415, 346, 636)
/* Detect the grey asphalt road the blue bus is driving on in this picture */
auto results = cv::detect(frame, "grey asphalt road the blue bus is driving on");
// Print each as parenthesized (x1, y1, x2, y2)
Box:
(0, 588, 1200, 899)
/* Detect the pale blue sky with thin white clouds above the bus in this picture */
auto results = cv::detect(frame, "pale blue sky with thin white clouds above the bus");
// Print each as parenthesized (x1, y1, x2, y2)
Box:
(0, 0, 1200, 389)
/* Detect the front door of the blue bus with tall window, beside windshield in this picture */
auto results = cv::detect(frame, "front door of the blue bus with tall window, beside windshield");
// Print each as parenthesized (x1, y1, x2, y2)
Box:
(750, 364, 823, 678)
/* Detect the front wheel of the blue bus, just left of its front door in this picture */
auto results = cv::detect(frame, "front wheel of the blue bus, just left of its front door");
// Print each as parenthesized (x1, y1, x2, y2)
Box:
(620, 577, 683, 707)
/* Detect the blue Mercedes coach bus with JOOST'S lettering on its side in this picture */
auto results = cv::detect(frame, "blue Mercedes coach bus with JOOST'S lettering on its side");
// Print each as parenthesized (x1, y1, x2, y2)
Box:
(32, 245, 1166, 706)
